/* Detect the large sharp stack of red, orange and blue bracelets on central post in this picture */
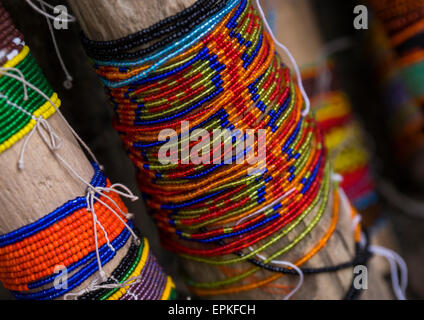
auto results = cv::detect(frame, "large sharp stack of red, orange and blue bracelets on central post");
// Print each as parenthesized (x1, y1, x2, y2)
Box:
(82, 0, 369, 298)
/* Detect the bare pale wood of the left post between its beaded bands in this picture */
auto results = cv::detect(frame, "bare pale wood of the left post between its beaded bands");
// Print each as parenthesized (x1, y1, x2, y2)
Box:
(0, 8, 130, 298)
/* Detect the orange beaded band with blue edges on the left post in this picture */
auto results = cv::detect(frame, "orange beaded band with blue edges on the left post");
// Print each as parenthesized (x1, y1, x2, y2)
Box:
(0, 165, 129, 298)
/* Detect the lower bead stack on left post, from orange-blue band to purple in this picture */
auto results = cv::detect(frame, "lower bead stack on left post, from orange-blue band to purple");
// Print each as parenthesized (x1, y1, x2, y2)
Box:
(0, 163, 175, 300)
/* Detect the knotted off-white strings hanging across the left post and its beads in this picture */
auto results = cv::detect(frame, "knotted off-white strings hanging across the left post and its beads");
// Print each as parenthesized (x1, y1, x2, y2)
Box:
(0, 67, 140, 281)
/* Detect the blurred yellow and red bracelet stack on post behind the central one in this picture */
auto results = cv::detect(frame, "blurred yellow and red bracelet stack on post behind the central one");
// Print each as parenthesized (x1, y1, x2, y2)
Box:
(302, 63, 378, 215)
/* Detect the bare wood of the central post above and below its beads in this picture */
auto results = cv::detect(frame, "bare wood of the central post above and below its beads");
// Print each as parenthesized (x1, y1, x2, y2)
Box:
(68, 0, 394, 299)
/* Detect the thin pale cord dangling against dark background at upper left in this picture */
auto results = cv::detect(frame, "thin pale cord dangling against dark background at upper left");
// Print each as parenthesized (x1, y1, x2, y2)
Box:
(26, 0, 76, 90)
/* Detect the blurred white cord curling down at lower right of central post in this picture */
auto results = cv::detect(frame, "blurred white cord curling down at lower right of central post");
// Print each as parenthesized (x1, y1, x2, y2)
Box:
(339, 188, 408, 300)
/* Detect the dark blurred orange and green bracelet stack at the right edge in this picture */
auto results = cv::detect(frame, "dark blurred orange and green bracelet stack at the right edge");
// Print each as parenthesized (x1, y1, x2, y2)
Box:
(370, 0, 424, 168)
